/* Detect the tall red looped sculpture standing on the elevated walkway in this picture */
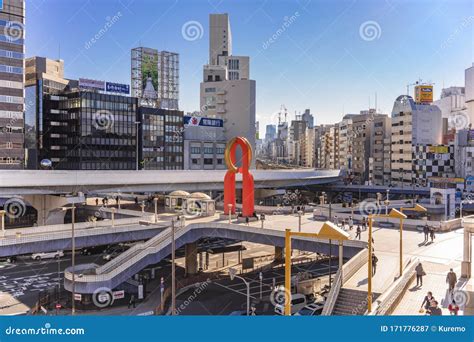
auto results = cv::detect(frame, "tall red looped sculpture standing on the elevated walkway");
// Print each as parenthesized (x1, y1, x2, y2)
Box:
(224, 137, 254, 217)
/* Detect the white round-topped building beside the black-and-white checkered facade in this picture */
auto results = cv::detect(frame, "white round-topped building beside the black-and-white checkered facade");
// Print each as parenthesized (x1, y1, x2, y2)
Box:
(391, 95, 443, 186)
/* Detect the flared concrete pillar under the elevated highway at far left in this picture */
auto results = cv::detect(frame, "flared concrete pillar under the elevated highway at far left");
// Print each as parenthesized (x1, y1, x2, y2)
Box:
(24, 195, 69, 226)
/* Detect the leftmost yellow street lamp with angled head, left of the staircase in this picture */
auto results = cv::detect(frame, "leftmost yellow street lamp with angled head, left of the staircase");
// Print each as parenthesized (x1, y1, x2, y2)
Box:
(285, 221, 350, 316)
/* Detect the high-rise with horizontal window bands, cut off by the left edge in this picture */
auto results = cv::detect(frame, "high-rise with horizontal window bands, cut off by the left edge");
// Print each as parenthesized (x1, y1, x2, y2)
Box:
(0, 0, 25, 169)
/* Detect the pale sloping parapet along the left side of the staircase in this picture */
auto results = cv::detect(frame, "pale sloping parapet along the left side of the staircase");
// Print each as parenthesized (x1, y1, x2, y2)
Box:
(321, 248, 369, 316)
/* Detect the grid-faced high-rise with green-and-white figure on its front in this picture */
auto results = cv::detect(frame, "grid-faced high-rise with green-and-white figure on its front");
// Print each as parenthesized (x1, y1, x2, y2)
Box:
(131, 47, 179, 110)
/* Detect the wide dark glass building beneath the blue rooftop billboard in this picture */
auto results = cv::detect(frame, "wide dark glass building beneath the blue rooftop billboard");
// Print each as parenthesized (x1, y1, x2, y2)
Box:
(40, 90, 137, 170)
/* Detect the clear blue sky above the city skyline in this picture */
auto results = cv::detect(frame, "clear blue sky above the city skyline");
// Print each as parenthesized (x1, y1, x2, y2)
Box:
(26, 0, 474, 130)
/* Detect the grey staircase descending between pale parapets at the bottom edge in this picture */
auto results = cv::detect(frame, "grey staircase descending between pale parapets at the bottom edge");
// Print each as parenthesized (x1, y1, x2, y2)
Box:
(332, 288, 380, 316)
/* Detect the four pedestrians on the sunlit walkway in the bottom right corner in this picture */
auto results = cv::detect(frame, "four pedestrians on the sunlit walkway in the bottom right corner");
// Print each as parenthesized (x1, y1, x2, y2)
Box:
(415, 262, 459, 316)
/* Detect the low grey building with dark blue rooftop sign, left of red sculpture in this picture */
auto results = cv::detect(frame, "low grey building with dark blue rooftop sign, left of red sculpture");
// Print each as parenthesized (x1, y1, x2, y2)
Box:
(184, 116, 227, 170)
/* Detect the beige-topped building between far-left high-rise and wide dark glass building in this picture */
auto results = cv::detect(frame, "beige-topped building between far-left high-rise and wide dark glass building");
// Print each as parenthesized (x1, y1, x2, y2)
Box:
(25, 57, 70, 169)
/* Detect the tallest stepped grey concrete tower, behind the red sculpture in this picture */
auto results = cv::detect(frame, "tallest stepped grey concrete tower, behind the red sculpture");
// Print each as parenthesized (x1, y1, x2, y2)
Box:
(200, 14, 256, 166)
